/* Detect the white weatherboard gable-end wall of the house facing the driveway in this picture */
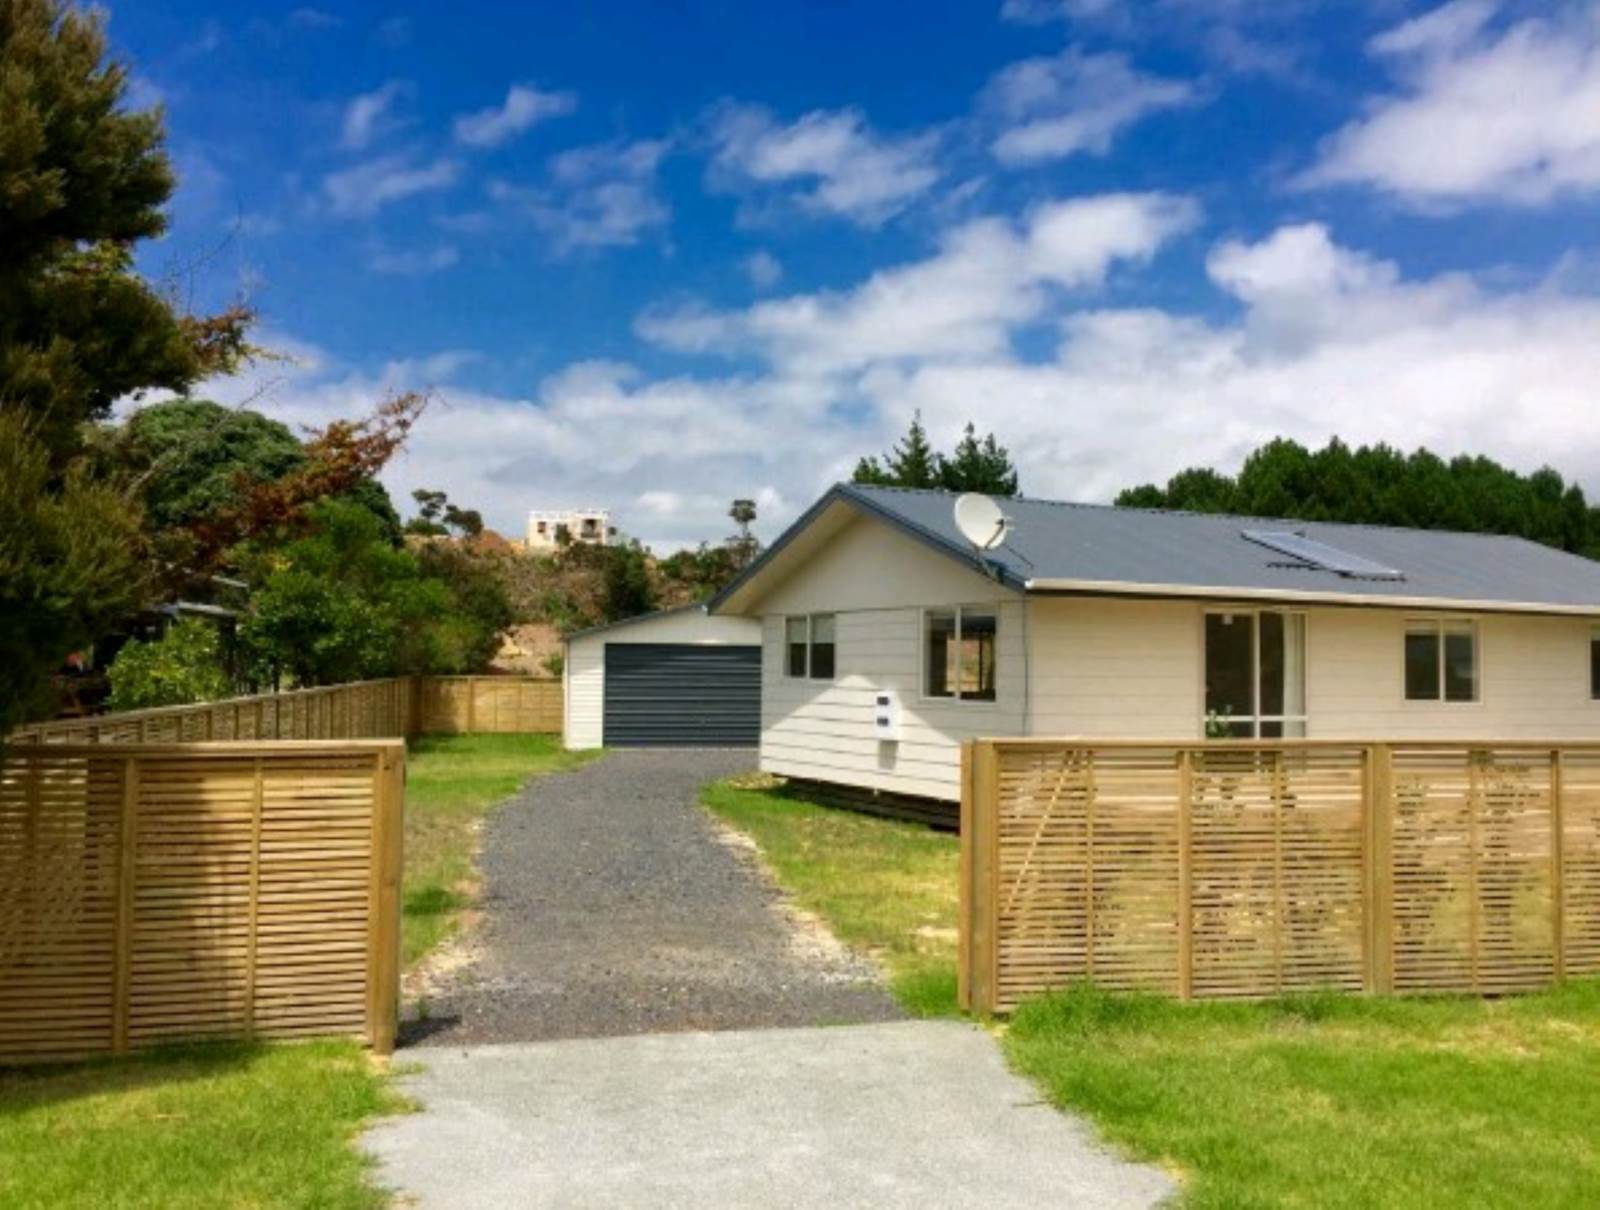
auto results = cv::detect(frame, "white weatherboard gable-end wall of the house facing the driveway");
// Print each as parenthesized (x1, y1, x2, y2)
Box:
(757, 520, 1024, 799)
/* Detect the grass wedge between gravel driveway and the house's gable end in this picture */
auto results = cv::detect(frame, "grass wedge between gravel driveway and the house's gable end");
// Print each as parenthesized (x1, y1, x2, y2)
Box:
(702, 781, 960, 1016)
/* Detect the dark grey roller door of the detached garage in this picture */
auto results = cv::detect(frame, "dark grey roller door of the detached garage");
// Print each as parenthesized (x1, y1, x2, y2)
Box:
(605, 643, 762, 747)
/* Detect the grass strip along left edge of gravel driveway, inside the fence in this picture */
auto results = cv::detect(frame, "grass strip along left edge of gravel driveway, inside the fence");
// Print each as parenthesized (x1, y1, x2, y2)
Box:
(400, 735, 597, 965)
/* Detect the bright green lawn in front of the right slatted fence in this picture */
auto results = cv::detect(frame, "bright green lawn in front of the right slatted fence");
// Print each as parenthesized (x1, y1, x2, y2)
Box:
(1005, 980, 1600, 1207)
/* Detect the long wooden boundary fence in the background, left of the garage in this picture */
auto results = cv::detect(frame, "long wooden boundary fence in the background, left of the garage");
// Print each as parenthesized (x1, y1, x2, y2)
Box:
(6, 677, 562, 744)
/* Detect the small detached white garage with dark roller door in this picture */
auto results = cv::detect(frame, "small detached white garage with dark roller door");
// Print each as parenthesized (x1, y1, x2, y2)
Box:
(563, 605, 762, 749)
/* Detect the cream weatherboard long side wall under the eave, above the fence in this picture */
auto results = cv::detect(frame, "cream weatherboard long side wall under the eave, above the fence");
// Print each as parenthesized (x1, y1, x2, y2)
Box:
(1030, 597, 1600, 739)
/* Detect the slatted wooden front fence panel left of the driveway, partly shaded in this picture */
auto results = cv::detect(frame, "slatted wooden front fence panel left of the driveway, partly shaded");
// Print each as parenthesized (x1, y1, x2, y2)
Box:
(0, 741, 405, 1063)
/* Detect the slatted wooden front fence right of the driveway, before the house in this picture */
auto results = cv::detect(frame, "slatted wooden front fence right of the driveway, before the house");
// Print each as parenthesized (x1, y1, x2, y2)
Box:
(960, 739, 1600, 1012)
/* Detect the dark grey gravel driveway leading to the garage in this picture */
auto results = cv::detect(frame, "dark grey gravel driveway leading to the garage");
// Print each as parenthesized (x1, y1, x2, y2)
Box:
(402, 749, 901, 1045)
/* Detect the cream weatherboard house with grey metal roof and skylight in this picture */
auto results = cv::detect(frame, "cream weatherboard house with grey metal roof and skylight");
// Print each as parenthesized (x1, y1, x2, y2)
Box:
(710, 485, 1600, 816)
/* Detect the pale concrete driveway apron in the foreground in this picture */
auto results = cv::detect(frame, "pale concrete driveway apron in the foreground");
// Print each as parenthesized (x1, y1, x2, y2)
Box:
(366, 1021, 1173, 1210)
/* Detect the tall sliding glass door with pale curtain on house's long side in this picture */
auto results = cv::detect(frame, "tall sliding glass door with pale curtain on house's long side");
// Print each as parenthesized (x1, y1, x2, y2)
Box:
(1205, 610, 1306, 739)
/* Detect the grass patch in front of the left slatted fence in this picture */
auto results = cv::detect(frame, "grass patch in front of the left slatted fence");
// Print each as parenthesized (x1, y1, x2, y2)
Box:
(0, 1042, 403, 1210)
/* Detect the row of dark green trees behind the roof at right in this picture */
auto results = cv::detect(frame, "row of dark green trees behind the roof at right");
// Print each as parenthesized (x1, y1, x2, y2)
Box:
(1117, 439, 1600, 557)
